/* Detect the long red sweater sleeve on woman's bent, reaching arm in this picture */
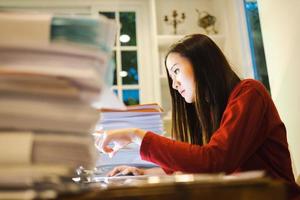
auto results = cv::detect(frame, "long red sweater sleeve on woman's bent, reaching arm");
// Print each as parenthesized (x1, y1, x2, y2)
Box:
(140, 87, 267, 173)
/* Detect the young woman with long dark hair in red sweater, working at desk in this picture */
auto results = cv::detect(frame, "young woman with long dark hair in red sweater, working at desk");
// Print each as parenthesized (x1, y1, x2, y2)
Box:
(98, 34, 300, 198)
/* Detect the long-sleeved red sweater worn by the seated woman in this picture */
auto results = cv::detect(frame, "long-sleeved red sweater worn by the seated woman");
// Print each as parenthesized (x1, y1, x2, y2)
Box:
(140, 79, 300, 198)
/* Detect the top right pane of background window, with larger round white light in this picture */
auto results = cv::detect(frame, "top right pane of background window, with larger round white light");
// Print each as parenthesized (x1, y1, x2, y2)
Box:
(120, 12, 136, 46)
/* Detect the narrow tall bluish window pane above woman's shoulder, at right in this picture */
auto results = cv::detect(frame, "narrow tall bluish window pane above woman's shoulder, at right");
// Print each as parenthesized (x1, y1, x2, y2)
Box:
(245, 0, 270, 91)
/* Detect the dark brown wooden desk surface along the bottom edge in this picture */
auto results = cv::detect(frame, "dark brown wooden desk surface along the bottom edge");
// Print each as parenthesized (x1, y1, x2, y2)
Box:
(58, 178, 286, 200)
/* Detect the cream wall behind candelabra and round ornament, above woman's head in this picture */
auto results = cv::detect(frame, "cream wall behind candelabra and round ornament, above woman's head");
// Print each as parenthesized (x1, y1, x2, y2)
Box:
(156, 0, 253, 78)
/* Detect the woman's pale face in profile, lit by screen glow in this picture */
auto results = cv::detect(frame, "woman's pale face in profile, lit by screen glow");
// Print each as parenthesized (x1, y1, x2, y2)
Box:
(166, 53, 195, 103)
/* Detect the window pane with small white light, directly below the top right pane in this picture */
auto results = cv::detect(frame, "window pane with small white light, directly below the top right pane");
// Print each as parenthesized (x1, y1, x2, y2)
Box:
(120, 51, 139, 85)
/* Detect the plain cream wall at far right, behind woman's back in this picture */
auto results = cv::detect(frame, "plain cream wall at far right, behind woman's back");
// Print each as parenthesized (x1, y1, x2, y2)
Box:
(258, 0, 300, 177)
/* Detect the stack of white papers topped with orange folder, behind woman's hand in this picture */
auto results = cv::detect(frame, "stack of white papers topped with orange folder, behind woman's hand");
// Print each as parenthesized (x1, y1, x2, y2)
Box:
(95, 104, 164, 169)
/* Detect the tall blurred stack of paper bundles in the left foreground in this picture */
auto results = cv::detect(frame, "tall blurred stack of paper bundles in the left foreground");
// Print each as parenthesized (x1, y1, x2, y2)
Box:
(0, 12, 117, 199)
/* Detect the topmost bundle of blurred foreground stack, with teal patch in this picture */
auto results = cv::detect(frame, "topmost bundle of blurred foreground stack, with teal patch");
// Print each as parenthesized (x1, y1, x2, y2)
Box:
(0, 12, 116, 53)
